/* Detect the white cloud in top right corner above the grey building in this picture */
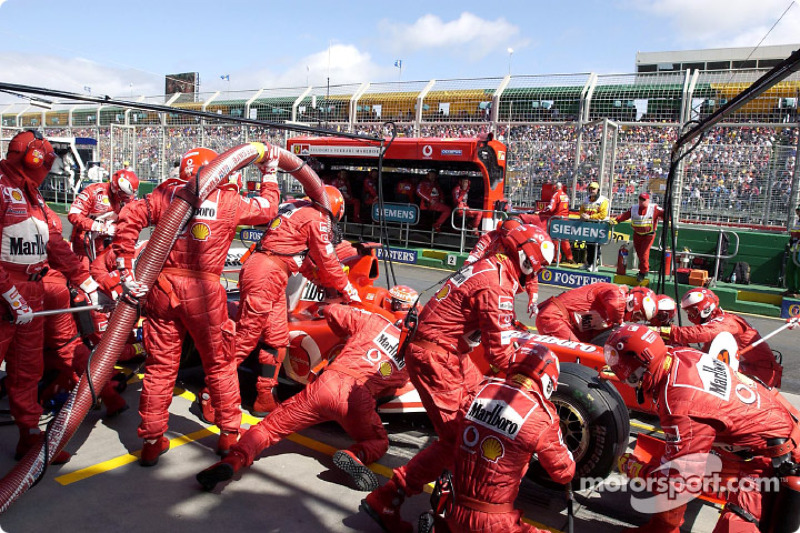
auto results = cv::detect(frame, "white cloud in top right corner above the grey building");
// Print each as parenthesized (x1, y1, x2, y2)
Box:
(630, 0, 800, 48)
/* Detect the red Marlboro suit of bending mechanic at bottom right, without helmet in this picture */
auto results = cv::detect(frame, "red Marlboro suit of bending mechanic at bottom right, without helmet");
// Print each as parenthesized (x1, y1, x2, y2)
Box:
(628, 348, 800, 533)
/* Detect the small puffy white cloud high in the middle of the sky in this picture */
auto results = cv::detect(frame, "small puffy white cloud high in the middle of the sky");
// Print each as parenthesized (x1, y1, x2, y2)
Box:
(378, 13, 527, 60)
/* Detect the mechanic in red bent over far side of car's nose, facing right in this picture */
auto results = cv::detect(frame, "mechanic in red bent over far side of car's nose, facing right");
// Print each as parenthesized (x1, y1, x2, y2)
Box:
(536, 282, 658, 342)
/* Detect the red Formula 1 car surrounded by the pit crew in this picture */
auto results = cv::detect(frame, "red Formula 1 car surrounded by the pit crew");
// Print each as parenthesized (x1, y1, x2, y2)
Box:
(177, 243, 635, 486)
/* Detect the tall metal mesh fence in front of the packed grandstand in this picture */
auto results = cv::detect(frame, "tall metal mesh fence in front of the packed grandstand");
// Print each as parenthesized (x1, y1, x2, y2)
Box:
(0, 70, 800, 227)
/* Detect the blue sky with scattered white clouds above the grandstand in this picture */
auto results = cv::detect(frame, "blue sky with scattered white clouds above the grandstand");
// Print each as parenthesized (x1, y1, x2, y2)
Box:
(0, 0, 800, 101)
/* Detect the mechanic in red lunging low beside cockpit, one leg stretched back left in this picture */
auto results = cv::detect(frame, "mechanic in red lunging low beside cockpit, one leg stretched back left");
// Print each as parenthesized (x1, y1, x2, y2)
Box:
(197, 286, 417, 491)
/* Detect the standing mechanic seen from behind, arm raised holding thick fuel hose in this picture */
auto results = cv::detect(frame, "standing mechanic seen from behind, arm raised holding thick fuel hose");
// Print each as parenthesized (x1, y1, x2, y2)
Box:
(112, 148, 279, 466)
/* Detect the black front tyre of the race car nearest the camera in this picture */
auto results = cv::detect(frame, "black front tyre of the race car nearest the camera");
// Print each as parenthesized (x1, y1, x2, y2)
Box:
(527, 363, 631, 488)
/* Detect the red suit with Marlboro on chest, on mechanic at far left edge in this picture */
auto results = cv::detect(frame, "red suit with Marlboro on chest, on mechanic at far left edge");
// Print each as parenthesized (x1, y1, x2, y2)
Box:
(0, 164, 89, 434)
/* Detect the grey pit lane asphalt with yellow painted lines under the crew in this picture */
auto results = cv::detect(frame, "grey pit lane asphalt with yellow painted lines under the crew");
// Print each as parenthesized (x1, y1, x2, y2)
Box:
(0, 220, 800, 533)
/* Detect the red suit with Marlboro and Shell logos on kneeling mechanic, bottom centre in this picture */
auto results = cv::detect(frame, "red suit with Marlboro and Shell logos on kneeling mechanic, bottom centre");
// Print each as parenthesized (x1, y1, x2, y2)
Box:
(447, 380, 575, 533)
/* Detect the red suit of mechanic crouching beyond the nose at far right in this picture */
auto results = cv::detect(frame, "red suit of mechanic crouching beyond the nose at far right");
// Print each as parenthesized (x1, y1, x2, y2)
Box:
(669, 310, 783, 388)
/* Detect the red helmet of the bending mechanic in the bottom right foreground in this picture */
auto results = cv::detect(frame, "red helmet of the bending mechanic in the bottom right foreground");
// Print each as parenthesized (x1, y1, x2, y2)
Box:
(603, 324, 667, 387)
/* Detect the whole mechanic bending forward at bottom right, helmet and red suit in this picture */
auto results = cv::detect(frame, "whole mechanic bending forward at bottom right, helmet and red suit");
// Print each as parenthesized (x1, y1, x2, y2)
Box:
(605, 324, 800, 533)
